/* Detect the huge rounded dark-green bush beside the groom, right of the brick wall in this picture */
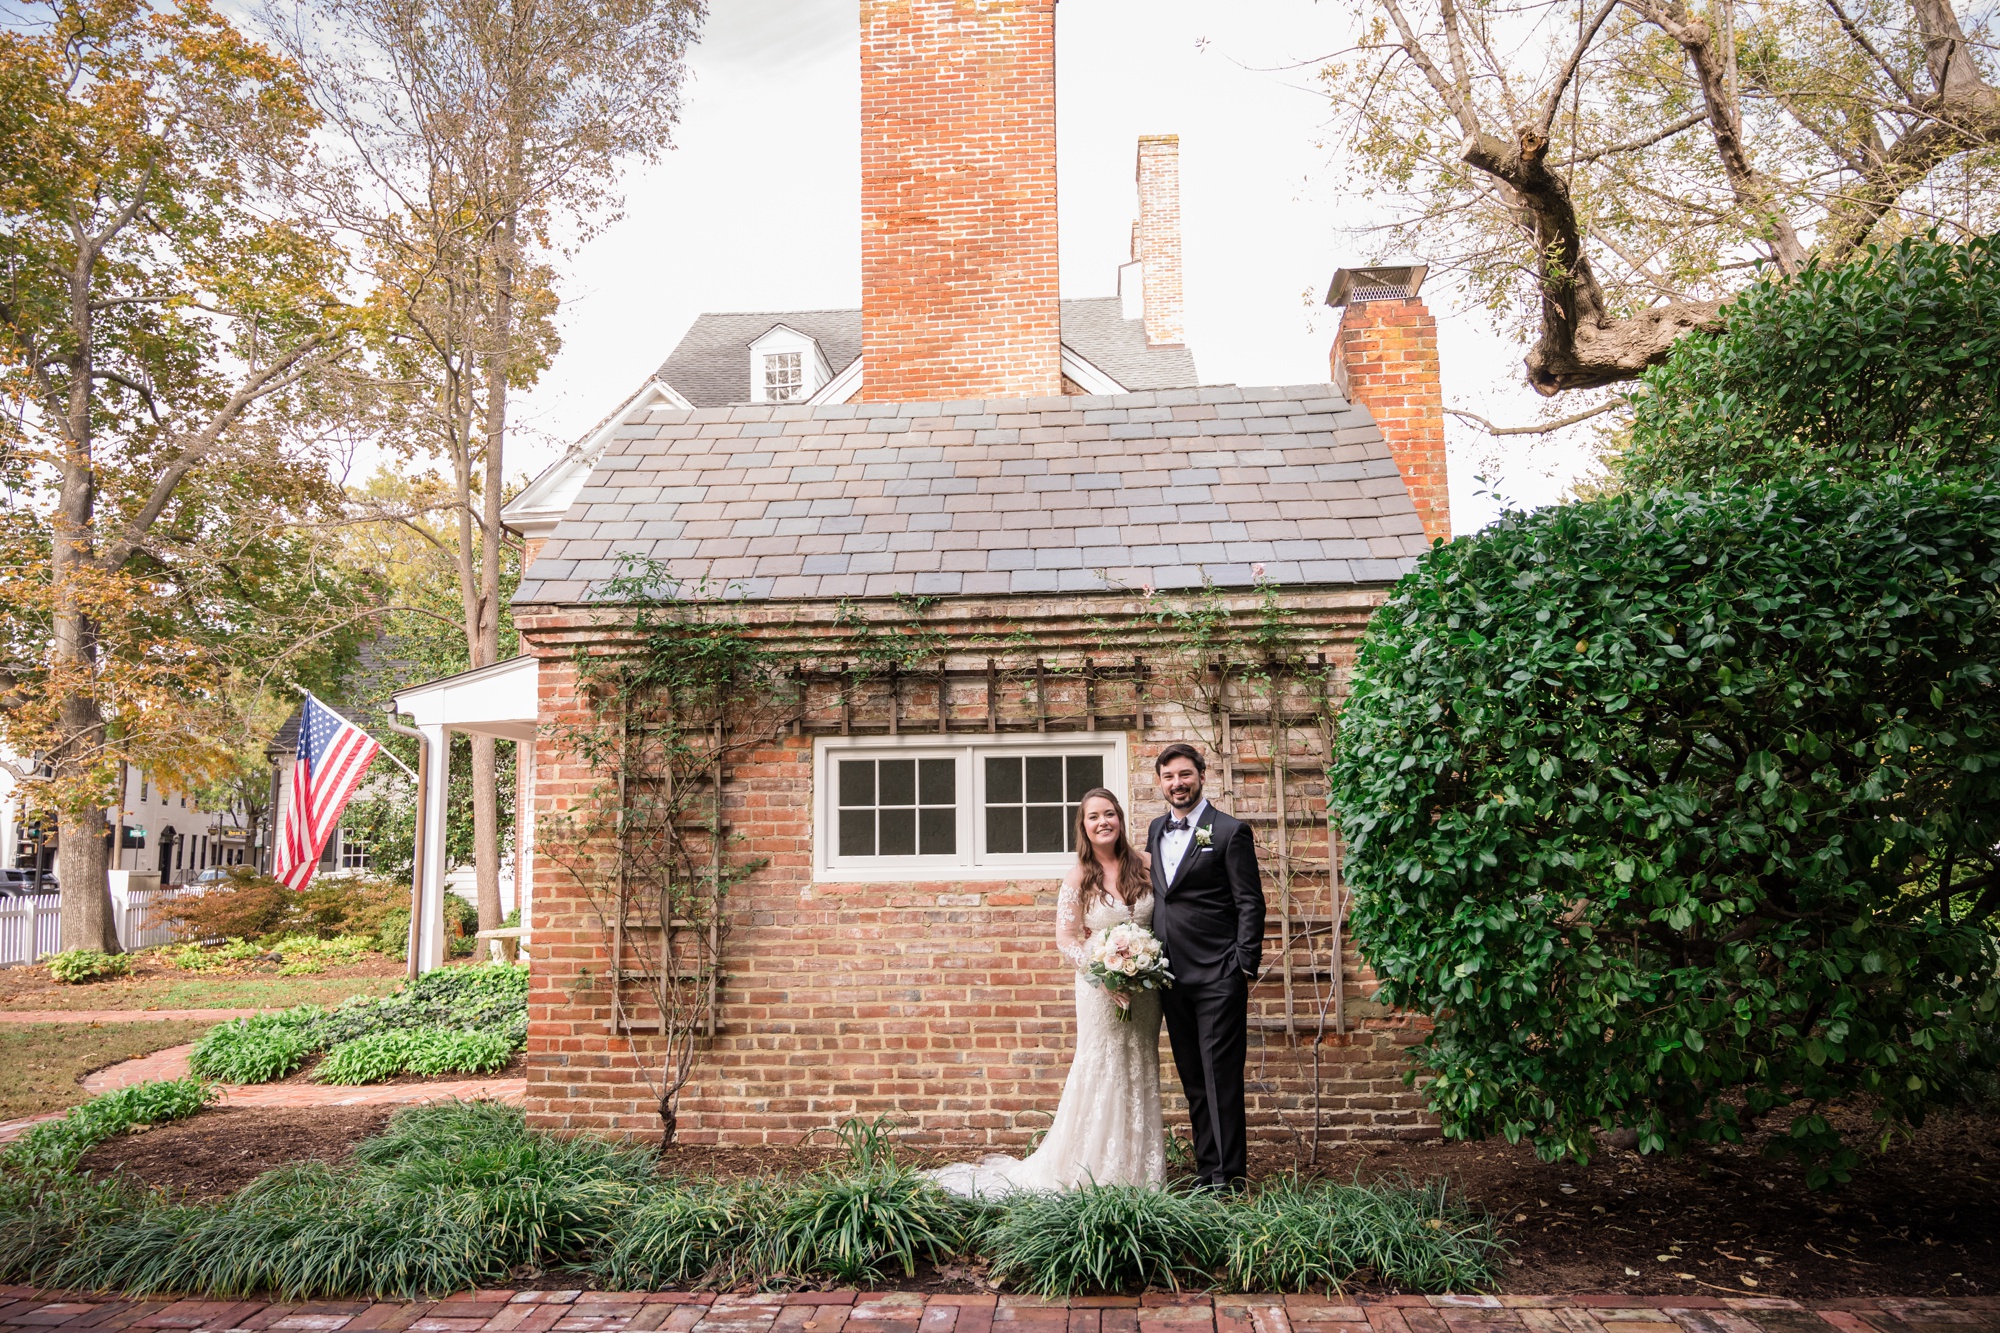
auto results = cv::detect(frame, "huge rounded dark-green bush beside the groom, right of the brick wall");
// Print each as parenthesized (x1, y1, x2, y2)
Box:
(1332, 480, 2000, 1179)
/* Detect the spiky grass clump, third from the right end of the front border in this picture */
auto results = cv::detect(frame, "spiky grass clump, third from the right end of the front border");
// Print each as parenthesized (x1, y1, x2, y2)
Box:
(764, 1169, 970, 1283)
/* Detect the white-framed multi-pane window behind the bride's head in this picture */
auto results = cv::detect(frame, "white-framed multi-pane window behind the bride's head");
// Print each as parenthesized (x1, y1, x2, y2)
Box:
(814, 737, 1124, 879)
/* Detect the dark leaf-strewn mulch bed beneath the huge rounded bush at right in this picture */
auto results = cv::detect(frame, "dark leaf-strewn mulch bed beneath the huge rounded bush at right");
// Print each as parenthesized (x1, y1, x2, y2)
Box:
(1254, 1113, 2000, 1299)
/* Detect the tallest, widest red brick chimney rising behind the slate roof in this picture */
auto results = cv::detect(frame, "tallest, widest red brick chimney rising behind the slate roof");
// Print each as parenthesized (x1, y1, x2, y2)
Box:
(862, 0, 1062, 402)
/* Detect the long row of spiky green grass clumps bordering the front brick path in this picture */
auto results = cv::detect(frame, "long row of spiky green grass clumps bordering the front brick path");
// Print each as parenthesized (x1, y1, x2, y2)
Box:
(0, 1093, 1498, 1299)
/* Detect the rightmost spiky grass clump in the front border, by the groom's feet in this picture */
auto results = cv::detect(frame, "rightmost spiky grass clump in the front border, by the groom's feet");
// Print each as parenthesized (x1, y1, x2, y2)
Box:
(1228, 1181, 1502, 1291)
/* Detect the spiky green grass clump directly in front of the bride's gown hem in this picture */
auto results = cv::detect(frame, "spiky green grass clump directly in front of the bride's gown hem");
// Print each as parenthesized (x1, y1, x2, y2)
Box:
(986, 1185, 1228, 1297)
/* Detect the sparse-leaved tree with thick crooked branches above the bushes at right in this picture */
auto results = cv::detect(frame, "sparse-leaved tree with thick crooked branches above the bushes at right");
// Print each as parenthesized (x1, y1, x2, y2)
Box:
(1324, 0, 2000, 394)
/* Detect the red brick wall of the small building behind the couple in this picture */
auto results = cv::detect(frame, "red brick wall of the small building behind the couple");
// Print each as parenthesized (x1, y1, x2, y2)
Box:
(522, 596, 1434, 1147)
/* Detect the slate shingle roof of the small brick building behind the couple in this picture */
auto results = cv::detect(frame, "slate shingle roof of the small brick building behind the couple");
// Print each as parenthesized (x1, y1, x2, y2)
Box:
(514, 384, 1424, 604)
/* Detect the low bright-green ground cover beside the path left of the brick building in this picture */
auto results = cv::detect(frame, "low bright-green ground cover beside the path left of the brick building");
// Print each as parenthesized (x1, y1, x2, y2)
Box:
(190, 963, 528, 1083)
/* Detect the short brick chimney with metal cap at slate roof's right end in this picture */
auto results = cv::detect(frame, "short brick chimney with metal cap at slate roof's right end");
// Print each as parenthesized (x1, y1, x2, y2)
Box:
(1326, 264, 1452, 540)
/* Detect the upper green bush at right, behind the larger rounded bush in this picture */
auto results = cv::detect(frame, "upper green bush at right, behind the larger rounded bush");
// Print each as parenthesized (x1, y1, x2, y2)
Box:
(1616, 236, 2000, 490)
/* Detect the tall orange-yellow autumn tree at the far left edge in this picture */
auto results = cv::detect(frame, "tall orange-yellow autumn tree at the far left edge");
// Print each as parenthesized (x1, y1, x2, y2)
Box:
(0, 0, 350, 949)
